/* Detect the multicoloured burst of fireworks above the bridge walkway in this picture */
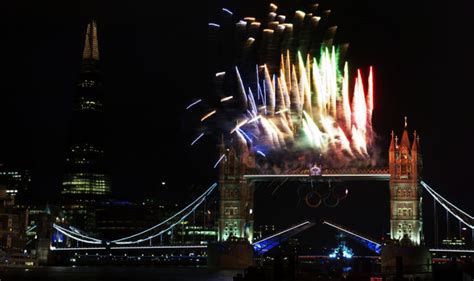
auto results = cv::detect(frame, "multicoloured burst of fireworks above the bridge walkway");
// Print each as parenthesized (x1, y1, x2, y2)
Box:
(192, 4, 375, 166)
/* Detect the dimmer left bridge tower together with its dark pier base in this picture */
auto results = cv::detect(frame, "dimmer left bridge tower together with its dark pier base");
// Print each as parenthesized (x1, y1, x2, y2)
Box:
(207, 140, 253, 269)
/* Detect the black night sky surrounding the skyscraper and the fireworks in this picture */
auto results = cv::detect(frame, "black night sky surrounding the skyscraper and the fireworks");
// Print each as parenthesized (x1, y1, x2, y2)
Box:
(0, 0, 474, 243)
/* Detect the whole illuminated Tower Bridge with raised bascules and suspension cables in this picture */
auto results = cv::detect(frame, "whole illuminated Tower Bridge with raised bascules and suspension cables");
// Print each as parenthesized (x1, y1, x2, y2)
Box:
(41, 120, 474, 272)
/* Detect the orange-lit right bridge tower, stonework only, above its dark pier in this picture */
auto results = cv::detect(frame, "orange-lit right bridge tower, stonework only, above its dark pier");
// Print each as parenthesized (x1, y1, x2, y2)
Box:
(389, 117, 423, 246)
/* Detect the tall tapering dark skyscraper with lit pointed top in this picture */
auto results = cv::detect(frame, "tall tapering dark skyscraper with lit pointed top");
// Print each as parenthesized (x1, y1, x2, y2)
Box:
(61, 20, 110, 197)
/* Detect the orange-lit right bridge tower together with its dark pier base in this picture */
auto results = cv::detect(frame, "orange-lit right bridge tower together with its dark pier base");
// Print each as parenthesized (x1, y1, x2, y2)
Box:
(381, 117, 432, 280)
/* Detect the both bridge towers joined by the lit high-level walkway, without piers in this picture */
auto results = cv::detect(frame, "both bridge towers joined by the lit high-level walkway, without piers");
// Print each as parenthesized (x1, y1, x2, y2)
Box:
(215, 119, 423, 245)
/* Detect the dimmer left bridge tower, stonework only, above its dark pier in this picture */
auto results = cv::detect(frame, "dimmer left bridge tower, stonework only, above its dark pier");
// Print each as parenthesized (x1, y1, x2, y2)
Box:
(218, 137, 253, 243)
